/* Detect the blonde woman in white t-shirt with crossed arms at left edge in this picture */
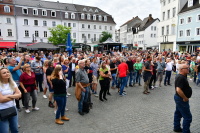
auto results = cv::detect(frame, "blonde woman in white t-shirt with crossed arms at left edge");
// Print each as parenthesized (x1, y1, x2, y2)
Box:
(0, 68, 21, 133)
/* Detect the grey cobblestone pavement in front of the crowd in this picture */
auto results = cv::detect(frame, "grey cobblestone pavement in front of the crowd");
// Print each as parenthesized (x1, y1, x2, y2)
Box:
(19, 75, 200, 133)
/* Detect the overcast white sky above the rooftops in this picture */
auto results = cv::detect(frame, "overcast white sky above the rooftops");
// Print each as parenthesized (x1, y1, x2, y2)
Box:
(47, 0, 160, 29)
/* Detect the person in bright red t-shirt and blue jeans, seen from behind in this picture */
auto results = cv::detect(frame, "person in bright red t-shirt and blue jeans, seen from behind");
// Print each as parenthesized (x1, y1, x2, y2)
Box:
(118, 59, 129, 96)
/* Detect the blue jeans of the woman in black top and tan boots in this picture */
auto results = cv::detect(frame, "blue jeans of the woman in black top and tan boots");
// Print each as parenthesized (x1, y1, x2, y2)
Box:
(54, 96, 67, 119)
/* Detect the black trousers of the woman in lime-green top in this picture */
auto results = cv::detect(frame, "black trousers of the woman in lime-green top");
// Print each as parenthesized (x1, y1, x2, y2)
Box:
(99, 80, 109, 100)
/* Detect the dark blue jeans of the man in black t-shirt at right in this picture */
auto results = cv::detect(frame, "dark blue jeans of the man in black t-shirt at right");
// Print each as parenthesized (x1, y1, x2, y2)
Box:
(174, 94, 192, 133)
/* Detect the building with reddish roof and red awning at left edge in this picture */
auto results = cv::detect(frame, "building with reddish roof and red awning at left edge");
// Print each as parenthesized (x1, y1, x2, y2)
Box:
(0, 0, 17, 48)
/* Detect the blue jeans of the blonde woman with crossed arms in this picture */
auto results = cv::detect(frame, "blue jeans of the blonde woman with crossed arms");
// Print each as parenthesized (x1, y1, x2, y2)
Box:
(0, 107, 18, 133)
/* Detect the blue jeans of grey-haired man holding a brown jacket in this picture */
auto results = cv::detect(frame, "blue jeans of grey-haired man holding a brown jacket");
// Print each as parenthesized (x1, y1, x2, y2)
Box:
(78, 87, 89, 112)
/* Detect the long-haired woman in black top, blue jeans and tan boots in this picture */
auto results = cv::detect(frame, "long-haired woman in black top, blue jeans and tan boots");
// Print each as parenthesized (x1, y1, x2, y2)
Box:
(51, 65, 70, 125)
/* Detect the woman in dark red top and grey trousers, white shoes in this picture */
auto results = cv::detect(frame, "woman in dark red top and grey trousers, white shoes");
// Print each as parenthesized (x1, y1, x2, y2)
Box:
(19, 64, 39, 113)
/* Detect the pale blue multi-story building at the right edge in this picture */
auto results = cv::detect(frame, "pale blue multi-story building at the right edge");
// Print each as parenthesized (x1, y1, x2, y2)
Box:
(177, 0, 200, 53)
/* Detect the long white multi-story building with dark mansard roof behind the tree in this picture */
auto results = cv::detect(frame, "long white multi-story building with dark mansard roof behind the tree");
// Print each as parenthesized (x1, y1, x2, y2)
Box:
(0, 0, 116, 50)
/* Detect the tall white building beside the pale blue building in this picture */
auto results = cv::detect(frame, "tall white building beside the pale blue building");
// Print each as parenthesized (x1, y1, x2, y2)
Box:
(157, 0, 187, 51)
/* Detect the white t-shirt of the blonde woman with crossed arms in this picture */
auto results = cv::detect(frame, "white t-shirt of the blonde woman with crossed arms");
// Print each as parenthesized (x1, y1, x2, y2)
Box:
(0, 82, 17, 110)
